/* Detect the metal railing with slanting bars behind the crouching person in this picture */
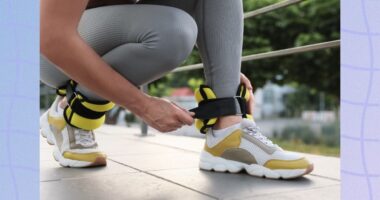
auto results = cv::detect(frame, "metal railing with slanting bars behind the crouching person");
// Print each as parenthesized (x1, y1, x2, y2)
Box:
(141, 0, 340, 136)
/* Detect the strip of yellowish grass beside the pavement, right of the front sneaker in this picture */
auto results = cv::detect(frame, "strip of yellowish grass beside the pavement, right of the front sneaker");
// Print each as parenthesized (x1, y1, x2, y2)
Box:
(272, 139, 340, 157)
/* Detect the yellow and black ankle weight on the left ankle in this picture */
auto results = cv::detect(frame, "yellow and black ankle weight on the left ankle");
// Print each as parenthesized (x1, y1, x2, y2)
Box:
(64, 80, 114, 130)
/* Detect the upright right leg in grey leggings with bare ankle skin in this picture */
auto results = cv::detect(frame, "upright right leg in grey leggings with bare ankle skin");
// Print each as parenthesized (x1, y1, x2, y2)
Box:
(142, 0, 243, 129)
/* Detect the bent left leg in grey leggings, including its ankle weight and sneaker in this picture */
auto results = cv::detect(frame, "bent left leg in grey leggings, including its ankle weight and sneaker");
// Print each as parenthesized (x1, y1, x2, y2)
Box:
(40, 5, 197, 167)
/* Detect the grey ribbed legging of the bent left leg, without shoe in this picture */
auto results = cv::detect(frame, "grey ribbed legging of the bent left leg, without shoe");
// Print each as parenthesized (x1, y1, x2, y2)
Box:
(40, 5, 197, 100)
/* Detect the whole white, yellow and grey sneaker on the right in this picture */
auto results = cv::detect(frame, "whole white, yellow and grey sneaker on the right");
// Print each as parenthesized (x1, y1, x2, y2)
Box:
(199, 119, 313, 179)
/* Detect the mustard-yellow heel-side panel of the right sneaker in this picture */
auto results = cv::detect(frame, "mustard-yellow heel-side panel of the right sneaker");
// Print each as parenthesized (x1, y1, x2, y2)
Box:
(204, 129, 242, 156)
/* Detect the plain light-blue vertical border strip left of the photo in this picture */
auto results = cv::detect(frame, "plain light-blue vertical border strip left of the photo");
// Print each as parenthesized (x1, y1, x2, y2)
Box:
(0, 0, 39, 200)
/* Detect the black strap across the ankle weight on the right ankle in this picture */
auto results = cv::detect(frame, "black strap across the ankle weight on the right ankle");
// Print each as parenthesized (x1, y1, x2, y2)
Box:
(190, 97, 244, 119)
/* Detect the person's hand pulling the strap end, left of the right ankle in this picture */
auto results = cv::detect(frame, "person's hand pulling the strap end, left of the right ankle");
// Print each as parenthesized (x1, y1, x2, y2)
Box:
(140, 97, 194, 132)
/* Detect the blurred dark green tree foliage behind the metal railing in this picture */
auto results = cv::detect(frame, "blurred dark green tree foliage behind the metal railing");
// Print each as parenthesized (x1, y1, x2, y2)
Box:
(151, 0, 340, 107)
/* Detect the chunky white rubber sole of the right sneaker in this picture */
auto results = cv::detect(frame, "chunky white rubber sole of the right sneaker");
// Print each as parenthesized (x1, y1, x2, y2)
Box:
(199, 151, 312, 179)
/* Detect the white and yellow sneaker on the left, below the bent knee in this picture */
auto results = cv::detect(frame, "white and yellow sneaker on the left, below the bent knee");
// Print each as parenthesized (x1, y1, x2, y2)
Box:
(40, 97, 107, 167)
